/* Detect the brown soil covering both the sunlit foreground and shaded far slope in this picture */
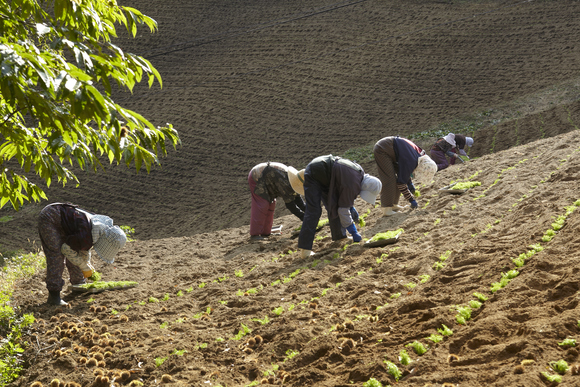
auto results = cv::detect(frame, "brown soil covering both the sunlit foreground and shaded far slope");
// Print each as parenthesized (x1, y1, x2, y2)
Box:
(0, 0, 580, 387)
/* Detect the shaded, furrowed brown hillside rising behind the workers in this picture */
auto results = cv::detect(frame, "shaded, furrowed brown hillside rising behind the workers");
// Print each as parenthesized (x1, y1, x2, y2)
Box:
(0, 0, 580, 255)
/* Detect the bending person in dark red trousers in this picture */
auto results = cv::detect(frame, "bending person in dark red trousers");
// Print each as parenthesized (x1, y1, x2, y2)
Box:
(248, 162, 305, 240)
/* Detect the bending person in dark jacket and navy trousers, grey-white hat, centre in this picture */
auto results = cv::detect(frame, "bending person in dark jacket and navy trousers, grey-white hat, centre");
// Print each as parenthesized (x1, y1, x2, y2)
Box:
(288, 155, 381, 258)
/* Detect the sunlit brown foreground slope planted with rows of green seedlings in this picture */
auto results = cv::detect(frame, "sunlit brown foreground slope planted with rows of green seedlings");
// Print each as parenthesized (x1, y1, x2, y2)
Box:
(12, 128, 580, 387)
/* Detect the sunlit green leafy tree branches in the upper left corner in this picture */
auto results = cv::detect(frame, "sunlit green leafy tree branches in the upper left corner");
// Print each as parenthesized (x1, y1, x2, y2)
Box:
(0, 0, 179, 209)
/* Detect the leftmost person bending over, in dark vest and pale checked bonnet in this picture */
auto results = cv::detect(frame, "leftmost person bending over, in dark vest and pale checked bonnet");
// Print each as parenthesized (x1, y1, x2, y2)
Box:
(38, 203, 127, 305)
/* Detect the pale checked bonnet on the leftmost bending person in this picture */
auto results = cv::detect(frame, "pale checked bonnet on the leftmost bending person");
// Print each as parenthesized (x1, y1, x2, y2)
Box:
(91, 215, 127, 263)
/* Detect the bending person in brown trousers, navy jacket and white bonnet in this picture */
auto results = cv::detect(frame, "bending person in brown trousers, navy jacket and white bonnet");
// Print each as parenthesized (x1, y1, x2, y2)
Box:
(373, 136, 437, 216)
